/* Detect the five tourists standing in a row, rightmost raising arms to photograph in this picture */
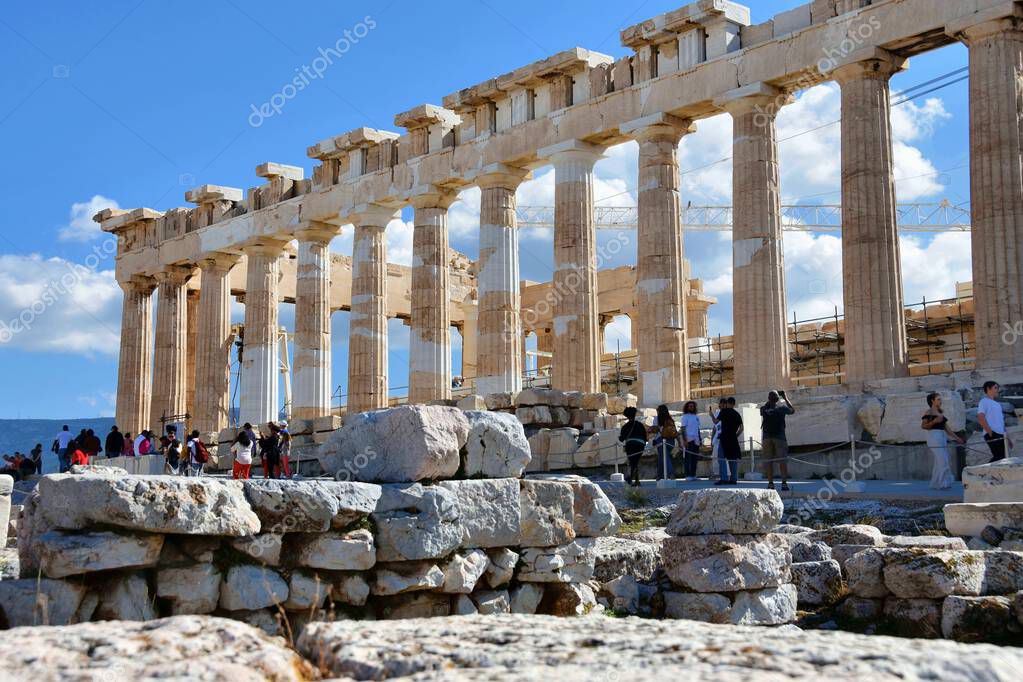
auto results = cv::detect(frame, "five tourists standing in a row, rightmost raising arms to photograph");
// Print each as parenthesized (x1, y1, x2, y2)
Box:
(618, 391, 796, 491)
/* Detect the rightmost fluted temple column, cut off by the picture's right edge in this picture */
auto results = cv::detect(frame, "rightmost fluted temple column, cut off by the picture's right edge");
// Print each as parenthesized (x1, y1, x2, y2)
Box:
(951, 5, 1023, 368)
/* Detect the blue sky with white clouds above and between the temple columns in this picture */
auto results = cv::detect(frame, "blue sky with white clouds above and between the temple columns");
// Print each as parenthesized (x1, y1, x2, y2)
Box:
(0, 0, 969, 418)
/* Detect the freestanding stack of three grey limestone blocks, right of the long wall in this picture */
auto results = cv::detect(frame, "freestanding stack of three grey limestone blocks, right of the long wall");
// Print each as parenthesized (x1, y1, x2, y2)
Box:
(661, 489, 797, 625)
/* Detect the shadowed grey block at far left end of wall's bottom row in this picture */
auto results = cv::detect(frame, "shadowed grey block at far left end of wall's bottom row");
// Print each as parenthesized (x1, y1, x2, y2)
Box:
(0, 578, 89, 625)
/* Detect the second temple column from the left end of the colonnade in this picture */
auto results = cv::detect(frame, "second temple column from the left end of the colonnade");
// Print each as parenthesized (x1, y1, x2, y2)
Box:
(149, 266, 192, 436)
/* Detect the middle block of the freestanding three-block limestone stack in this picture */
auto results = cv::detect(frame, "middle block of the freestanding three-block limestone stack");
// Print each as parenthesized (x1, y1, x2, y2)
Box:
(661, 535, 792, 592)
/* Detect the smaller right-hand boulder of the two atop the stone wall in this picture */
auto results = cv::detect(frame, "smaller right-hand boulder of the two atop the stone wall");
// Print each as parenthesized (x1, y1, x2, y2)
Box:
(465, 411, 531, 479)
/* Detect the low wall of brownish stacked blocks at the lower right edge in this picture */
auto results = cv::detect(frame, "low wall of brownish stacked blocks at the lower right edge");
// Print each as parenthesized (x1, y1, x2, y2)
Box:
(841, 539, 1023, 645)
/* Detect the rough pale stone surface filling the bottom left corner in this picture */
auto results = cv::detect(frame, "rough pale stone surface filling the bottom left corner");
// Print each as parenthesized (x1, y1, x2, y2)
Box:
(0, 616, 317, 682)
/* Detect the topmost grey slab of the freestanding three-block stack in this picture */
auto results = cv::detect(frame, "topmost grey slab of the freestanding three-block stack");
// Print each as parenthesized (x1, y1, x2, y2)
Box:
(665, 488, 785, 536)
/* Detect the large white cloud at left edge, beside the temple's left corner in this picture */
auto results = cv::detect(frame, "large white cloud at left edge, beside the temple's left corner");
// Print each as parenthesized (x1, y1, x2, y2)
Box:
(0, 255, 121, 356)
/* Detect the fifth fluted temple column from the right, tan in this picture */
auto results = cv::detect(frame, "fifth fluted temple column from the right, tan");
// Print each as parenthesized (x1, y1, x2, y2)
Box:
(537, 140, 603, 393)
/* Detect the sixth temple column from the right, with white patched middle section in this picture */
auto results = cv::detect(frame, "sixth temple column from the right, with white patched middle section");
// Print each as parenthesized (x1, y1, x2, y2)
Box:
(474, 165, 529, 396)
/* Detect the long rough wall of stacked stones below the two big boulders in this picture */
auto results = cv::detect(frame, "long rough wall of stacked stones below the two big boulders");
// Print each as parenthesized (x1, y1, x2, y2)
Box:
(0, 467, 620, 633)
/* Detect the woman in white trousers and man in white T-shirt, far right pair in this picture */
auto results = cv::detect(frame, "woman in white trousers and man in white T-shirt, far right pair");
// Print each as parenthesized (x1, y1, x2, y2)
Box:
(920, 381, 1013, 490)
